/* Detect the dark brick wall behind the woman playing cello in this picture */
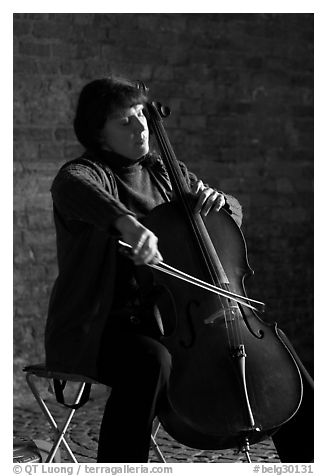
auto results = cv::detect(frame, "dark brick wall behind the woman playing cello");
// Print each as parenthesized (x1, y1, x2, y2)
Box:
(14, 13, 313, 396)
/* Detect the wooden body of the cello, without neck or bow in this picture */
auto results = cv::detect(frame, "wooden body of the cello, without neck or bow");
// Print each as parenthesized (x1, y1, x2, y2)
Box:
(144, 202, 302, 449)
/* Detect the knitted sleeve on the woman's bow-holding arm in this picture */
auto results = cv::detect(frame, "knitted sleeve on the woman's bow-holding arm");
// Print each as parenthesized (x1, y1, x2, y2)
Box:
(51, 163, 135, 232)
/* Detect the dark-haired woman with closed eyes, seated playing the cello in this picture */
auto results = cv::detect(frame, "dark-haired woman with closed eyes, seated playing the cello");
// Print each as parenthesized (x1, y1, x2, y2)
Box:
(45, 77, 312, 462)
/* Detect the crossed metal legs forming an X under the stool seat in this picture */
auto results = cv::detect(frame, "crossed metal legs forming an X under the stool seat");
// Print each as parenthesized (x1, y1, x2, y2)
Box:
(26, 373, 81, 463)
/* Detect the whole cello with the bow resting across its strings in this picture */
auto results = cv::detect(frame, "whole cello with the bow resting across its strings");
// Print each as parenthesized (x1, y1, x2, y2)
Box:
(127, 84, 303, 461)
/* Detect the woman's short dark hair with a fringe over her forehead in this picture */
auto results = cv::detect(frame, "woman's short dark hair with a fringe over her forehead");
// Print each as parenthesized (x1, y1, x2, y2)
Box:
(74, 75, 147, 150)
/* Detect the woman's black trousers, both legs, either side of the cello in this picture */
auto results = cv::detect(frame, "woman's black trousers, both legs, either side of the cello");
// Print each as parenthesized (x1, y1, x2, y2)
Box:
(97, 322, 313, 463)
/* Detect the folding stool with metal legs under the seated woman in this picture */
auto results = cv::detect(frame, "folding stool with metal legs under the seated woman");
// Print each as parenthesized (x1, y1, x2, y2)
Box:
(23, 364, 166, 463)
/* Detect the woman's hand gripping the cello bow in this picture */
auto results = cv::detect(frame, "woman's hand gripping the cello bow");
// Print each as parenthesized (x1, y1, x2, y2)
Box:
(115, 215, 163, 265)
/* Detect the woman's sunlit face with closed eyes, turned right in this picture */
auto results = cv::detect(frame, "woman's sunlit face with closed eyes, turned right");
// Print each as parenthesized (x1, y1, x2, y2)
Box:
(101, 104, 149, 160)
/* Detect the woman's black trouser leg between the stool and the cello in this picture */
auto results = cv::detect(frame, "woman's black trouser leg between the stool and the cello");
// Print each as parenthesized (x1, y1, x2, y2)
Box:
(97, 322, 171, 463)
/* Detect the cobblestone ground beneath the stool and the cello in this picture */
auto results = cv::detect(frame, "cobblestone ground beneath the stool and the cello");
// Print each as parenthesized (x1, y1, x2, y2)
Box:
(14, 384, 280, 463)
